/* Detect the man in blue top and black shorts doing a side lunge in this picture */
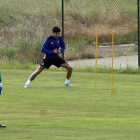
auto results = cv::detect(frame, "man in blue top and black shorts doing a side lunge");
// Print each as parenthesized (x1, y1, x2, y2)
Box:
(24, 26, 73, 88)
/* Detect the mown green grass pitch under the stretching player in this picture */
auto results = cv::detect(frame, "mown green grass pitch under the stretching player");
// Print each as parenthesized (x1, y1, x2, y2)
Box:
(0, 69, 140, 140)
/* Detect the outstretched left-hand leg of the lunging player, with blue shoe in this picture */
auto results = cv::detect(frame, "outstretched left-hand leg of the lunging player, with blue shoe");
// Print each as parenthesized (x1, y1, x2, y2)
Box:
(24, 66, 45, 88)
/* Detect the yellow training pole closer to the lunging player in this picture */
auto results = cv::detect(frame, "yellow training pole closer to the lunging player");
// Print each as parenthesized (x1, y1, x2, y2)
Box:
(95, 26, 98, 91)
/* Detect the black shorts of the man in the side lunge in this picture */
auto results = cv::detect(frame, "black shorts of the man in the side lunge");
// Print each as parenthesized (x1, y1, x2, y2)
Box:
(40, 57, 67, 69)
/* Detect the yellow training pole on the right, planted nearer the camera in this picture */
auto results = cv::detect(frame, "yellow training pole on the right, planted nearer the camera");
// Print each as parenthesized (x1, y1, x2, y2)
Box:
(111, 30, 114, 98)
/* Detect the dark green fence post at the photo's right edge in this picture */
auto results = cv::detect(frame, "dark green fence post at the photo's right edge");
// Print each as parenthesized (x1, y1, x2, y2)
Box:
(137, 0, 140, 67)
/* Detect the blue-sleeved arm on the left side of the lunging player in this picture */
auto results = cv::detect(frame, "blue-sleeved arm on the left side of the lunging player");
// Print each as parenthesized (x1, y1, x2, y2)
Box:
(41, 39, 54, 54)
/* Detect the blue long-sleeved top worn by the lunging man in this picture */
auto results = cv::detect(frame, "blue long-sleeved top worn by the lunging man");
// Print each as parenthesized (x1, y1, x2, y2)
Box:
(41, 35, 65, 59)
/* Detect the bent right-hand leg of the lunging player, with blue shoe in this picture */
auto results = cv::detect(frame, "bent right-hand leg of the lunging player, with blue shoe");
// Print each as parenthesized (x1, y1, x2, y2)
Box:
(60, 63, 73, 87)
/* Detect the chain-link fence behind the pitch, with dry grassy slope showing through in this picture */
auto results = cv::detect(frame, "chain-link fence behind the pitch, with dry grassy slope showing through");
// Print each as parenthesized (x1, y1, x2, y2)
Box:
(0, 0, 138, 68)
